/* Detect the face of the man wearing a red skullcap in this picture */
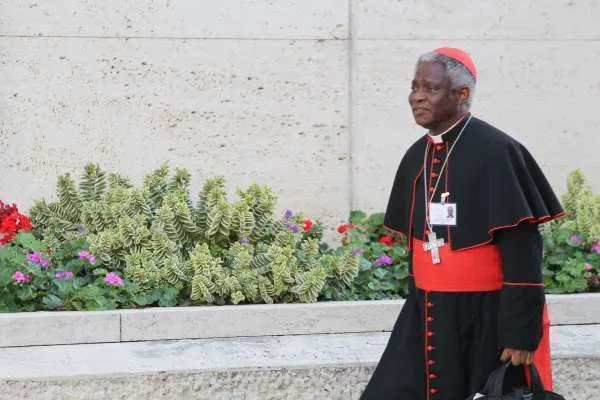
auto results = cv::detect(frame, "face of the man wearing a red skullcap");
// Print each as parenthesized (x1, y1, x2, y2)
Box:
(408, 62, 460, 130)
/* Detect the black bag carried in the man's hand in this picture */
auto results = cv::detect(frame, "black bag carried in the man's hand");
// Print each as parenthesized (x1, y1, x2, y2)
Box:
(467, 361, 566, 400)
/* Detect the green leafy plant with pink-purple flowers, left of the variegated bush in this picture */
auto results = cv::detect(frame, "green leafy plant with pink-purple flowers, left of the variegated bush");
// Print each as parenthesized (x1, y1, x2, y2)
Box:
(0, 232, 134, 312)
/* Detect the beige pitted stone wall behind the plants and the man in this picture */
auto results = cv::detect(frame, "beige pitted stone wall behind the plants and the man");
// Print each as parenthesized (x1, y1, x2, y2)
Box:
(0, 0, 600, 230)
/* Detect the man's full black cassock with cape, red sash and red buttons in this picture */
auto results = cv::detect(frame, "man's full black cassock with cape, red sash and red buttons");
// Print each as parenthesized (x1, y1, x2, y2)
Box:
(361, 115, 563, 400)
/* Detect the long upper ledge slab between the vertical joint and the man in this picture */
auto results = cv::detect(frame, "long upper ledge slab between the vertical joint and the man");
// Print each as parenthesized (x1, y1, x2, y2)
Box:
(121, 300, 403, 341)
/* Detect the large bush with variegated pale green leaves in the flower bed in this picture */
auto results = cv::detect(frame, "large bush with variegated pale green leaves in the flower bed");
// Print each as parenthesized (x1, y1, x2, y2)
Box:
(25, 164, 359, 305)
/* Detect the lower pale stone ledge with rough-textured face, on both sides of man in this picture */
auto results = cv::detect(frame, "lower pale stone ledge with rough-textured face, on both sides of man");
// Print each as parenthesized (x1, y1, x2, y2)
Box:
(0, 325, 600, 400)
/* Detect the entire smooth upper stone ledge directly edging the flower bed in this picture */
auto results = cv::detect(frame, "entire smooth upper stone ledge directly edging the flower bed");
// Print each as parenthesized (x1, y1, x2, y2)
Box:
(0, 293, 600, 347)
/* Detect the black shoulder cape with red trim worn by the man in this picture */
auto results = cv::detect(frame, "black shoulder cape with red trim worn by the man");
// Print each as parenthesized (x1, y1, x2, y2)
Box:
(384, 117, 563, 250)
